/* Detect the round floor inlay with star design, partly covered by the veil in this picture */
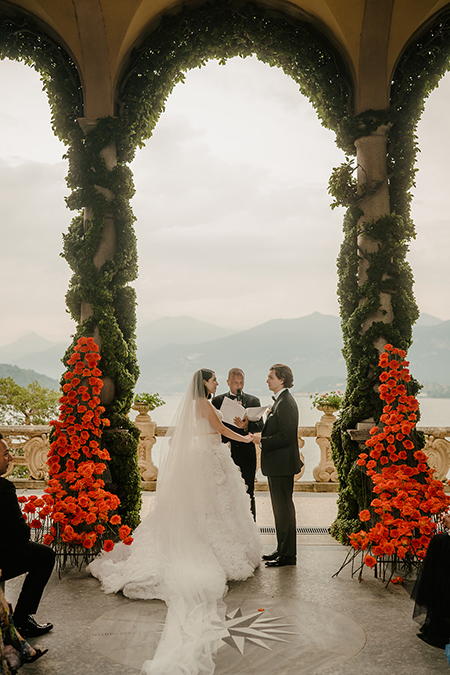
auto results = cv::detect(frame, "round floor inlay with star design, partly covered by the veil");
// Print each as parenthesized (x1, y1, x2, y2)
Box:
(90, 590, 366, 675)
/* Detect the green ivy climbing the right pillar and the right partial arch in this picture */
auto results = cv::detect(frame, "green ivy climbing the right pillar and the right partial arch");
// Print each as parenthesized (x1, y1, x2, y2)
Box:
(330, 10, 450, 543)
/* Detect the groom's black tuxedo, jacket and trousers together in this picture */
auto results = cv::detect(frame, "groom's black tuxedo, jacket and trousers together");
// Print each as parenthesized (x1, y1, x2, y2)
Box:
(261, 389, 303, 556)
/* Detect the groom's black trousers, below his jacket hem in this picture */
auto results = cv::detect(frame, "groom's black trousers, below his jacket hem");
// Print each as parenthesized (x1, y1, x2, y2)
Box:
(267, 475, 297, 556)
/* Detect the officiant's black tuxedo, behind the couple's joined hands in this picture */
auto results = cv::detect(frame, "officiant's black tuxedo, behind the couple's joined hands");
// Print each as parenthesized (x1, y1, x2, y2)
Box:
(211, 392, 263, 520)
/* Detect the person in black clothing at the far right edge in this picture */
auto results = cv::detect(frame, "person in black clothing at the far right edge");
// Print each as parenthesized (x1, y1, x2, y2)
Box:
(412, 515, 450, 649)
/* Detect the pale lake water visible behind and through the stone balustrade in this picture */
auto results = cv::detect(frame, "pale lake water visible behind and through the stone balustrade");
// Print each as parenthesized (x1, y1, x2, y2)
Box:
(130, 393, 450, 481)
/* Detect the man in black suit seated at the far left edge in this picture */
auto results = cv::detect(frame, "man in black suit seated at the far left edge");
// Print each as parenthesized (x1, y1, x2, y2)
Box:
(0, 434, 55, 637)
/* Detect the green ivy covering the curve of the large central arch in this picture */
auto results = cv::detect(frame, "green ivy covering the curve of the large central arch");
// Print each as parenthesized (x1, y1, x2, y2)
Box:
(116, 3, 354, 152)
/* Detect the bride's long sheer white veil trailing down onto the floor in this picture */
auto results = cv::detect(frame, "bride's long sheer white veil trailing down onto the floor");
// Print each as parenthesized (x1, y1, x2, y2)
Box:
(143, 370, 226, 675)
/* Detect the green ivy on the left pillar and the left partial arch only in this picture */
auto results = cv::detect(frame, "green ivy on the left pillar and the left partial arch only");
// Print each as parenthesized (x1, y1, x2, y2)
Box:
(0, 7, 140, 528)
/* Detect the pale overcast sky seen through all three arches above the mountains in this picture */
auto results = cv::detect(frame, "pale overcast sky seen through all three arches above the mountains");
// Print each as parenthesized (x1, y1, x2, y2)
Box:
(0, 58, 450, 345)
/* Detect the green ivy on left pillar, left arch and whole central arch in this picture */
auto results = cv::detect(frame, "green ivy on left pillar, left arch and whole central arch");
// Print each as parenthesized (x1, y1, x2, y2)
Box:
(0, 2, 351, 527)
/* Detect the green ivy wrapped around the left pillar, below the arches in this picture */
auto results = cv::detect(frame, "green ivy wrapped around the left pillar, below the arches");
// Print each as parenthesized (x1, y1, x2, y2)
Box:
(60, 118, 141, 528)
